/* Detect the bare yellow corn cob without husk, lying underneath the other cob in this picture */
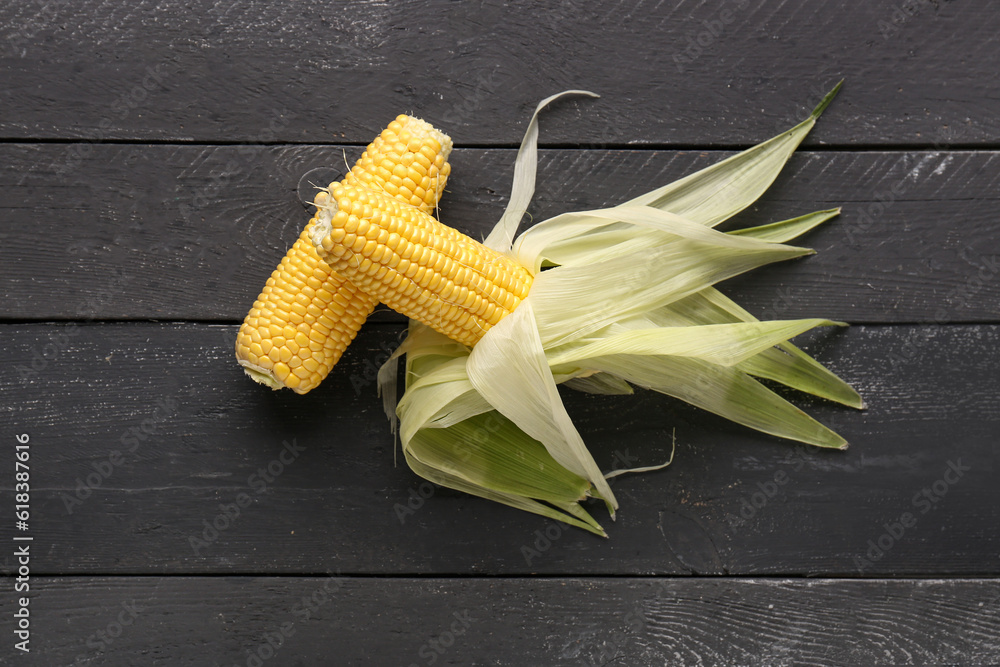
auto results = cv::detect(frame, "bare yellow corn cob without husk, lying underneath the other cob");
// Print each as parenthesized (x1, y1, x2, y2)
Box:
(236, 116, 452, 394)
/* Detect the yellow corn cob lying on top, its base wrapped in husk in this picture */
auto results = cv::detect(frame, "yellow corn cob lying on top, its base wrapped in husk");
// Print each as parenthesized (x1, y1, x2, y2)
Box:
(310, 182, 532, 346)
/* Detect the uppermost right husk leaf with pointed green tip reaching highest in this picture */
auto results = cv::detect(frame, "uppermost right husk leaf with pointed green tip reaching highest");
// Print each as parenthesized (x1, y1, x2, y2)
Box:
(625, 81, 843, 227)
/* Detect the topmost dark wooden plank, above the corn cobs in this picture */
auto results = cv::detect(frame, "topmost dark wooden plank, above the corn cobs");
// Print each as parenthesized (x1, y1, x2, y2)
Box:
(0, 0, 1000, 146)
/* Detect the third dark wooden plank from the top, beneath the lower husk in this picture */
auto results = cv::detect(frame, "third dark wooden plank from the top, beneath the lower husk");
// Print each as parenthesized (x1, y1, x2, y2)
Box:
(0, 323, 1000, 576)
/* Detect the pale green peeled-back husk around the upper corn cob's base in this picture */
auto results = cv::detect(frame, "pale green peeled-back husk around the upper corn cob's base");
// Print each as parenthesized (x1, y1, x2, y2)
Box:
(379, 84, 862, 535)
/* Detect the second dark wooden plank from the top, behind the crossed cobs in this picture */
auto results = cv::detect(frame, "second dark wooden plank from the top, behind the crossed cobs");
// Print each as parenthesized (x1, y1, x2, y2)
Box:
(0, 144, 1000, 323)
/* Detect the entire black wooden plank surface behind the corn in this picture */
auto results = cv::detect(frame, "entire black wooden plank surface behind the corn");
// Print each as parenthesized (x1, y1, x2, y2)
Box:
(0, 0, 1000, 667)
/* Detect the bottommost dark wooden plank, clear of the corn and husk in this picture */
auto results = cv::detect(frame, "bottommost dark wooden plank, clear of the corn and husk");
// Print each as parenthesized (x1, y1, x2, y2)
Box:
(0, 577, 1000, 667)
